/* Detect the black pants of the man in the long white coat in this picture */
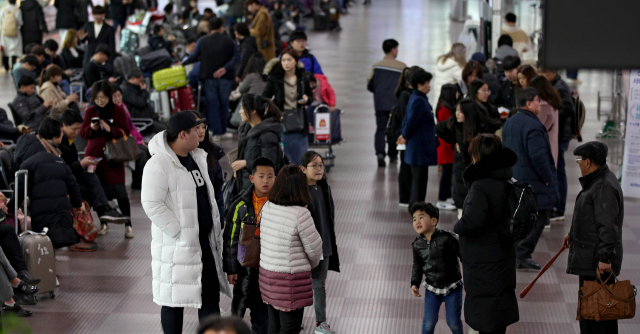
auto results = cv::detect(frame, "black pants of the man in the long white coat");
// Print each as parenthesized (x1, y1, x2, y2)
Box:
(160, 240, 220, 334)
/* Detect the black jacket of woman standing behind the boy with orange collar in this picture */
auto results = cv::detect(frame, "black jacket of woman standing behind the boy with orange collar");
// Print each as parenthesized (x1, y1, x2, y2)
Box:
(238, 117, 282, 189)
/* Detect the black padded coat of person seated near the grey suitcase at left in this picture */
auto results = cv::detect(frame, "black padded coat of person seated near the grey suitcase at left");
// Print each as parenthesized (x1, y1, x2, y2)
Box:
(9, 151, 82, 248)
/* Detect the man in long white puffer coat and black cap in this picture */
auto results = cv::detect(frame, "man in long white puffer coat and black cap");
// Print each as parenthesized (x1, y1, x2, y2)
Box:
(141, 111, 231, 334)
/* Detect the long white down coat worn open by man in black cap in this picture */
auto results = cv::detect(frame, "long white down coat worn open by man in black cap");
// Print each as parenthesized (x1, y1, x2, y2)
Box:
(141, 131, 231, 308)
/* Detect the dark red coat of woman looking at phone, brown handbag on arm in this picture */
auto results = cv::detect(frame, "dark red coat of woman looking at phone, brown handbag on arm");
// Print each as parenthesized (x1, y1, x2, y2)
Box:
(80, 105, 131, 185)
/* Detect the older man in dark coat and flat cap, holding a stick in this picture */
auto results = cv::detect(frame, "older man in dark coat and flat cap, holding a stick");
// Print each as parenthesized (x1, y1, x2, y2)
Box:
(564, 141, 624, 334)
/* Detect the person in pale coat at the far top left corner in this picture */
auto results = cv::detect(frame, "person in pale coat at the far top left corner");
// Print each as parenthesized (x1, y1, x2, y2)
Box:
(0, 0, 23, 70)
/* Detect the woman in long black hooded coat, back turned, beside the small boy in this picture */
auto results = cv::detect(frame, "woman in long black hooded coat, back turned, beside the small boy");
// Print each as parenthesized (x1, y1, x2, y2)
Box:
(453, 134, 519, 333)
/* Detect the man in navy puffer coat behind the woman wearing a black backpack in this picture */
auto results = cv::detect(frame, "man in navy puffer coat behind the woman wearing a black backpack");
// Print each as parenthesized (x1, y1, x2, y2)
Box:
(502, 87, 558, 270)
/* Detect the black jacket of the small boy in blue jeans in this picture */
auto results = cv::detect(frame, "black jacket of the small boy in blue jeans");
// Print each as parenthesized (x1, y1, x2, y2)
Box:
(411, 228, 462, 288)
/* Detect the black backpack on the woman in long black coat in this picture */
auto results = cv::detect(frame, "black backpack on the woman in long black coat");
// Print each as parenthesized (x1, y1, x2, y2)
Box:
(506, 178, 538, 241)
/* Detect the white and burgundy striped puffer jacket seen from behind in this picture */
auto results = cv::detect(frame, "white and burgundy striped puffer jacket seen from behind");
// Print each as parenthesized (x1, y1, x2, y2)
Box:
(259, 202, 322, 310)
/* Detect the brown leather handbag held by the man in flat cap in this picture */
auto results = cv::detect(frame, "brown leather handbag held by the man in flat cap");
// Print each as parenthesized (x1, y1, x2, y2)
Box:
(576, 270, 636, 321)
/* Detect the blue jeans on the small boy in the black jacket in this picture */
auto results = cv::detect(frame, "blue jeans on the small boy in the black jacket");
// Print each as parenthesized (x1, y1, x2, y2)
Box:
(422, 286, 464, 334)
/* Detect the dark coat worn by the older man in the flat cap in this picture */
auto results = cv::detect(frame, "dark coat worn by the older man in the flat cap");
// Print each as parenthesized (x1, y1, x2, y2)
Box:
(567, 165, 624, 277)
